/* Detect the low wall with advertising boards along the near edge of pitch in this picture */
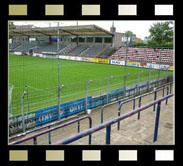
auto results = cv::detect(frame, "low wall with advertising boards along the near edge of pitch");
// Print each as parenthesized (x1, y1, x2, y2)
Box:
(9, 76, 173, 136)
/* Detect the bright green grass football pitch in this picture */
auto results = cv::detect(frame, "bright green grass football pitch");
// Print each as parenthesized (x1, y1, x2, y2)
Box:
(9, 55, 172, 115)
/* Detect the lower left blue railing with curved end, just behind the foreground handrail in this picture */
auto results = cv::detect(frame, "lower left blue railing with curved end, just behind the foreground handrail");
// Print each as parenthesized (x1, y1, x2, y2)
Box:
(9, 115, 92, 145)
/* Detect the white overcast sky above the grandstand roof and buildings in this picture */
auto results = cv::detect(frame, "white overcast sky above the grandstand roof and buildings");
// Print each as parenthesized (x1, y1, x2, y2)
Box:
(14, 20, 173, 39)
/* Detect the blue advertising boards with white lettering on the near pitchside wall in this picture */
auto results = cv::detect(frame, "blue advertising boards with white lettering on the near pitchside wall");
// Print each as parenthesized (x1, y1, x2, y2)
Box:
(35, 88, 123, 126)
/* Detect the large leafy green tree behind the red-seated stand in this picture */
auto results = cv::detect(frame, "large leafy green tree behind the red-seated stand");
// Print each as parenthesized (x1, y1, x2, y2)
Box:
(148, 21, 173, 47)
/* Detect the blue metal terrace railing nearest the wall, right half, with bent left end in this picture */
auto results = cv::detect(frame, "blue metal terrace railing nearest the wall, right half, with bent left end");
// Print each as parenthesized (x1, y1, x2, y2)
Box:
(101, 83, 172, 123)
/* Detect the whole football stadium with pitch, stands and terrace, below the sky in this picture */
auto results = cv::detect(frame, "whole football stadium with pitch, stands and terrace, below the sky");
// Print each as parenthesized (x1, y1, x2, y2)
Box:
(8, 22, 174, 145)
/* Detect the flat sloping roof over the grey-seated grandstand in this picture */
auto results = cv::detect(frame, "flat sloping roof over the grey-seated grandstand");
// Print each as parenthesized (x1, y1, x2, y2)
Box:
(9, 25, 112, 36)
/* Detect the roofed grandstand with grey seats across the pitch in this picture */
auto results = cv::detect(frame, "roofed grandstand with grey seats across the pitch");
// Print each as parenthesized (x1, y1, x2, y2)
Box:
(9, 25, 116, 57)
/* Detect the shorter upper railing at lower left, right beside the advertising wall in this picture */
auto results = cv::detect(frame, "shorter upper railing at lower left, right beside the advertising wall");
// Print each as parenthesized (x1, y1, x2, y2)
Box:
(9, 115, 80, 140)
